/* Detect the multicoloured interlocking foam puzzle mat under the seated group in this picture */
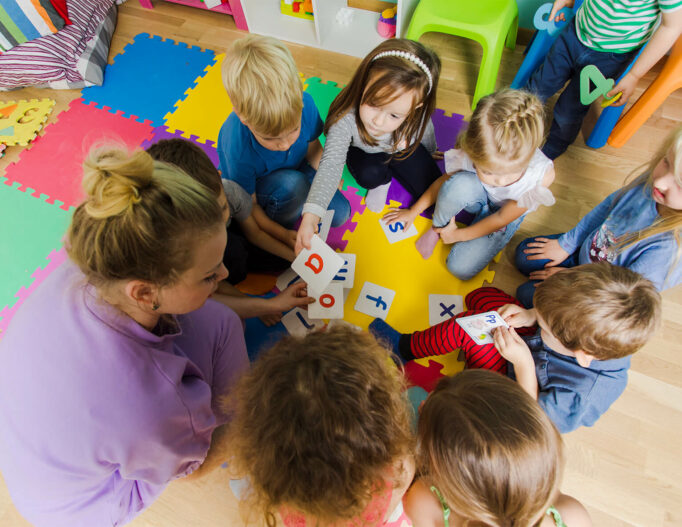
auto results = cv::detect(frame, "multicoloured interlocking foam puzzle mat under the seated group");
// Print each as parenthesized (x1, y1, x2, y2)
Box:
(0, 33, 494, 390)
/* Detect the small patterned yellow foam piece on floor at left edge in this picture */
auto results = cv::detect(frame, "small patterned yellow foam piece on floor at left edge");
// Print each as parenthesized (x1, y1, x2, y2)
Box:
(0, 99, 55, 146)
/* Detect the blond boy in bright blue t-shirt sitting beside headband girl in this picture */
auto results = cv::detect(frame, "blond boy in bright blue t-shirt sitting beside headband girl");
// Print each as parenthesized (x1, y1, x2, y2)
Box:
(218, 35, 350, 230)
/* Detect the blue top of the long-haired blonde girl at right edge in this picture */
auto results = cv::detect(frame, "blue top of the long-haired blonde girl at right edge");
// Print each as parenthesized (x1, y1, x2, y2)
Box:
(558, 184, 682, 291)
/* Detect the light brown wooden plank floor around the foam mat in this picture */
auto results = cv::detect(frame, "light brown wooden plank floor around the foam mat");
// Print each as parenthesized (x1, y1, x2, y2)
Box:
(0, 0, 682, 527)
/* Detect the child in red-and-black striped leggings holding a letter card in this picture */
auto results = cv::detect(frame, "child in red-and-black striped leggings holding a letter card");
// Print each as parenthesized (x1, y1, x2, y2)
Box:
(370, 262, 661, 432)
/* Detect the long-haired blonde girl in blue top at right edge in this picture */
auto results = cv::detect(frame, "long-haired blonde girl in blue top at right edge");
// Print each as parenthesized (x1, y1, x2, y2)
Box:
(516, 127, 682, 307)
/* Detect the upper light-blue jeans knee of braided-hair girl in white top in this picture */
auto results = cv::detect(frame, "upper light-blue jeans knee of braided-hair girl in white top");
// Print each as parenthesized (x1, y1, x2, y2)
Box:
(433, 170, 488, 227)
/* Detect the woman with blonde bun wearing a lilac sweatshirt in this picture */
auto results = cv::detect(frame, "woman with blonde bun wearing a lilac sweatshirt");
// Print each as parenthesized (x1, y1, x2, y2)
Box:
(0, 145, 248, 527)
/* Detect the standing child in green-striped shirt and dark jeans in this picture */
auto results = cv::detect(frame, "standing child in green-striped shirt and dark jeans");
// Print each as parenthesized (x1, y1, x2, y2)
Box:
(526, 0, 682, 159)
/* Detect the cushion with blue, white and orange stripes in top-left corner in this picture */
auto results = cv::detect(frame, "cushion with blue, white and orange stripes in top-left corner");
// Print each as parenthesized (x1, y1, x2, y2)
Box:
(0, 0, 66, 51)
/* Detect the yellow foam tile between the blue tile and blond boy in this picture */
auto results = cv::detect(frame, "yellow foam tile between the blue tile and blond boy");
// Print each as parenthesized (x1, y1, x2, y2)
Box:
(164, 53, 232, 143)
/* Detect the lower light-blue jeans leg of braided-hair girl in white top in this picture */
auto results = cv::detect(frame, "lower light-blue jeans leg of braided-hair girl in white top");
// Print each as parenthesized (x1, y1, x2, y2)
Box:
(446, 205, 524, 280)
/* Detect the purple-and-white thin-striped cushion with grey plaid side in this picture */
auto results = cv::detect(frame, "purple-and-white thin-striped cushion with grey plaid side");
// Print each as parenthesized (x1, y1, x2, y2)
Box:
(0, 0, 116, 91)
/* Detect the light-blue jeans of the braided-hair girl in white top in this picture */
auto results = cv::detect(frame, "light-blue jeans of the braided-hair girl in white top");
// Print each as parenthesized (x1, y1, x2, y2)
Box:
(433, 171, 525, 280)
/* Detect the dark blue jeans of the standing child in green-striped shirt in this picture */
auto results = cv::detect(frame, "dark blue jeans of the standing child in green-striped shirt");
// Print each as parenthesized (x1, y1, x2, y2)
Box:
(525, 21, 638, 159)
